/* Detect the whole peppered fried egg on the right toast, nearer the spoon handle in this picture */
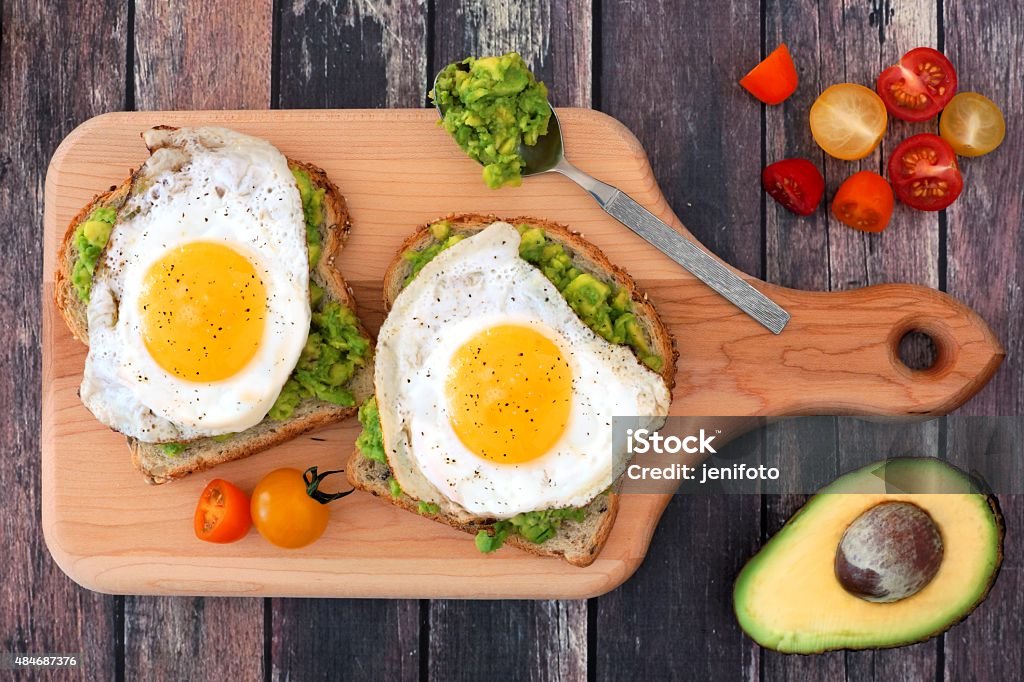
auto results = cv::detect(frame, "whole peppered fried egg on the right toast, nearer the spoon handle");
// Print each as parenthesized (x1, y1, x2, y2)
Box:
(376, 222, 670, 518)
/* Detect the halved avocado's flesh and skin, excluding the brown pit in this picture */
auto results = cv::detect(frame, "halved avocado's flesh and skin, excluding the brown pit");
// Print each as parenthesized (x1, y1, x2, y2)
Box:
(733, 458, 1004, 653)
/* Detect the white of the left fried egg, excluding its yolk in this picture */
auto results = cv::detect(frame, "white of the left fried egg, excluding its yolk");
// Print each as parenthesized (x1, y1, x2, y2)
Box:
(80, 128, 310, 442)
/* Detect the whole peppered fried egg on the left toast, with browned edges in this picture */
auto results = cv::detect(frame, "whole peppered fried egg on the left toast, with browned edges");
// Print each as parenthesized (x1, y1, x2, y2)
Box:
(80, 128, 310, 442)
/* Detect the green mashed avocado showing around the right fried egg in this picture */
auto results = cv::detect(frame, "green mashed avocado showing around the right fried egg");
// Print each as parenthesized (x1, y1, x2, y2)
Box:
(355, 220, 647, 553)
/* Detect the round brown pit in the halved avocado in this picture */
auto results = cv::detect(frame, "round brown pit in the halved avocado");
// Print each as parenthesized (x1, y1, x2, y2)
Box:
(836, 502, 943, 603)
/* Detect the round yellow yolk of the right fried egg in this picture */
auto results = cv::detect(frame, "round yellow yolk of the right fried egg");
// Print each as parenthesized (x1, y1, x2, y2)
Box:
(445, 325, 572, 464)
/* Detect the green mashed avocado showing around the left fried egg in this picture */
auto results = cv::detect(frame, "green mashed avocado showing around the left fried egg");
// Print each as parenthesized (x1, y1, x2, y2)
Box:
(72, 168, 370, 457)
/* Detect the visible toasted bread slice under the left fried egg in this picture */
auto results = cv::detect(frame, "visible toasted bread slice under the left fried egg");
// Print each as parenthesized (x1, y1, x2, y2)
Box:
(54, 146, 374, 484)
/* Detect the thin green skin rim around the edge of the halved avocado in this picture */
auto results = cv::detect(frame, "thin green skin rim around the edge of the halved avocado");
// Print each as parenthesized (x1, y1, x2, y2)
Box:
(733, 457, 1006, 655)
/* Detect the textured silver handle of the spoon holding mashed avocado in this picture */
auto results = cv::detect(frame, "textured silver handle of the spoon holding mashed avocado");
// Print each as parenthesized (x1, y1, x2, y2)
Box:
(552, 161, 790, 334)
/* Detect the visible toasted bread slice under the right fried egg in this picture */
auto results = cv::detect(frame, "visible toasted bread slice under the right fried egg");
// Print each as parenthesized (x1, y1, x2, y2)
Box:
(346, 214, 678, 566)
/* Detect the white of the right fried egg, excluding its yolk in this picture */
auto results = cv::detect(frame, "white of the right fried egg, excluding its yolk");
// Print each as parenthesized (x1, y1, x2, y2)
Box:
(376, 222, 670, 518)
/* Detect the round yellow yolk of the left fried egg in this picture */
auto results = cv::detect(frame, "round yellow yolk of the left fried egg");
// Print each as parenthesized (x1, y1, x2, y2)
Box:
(139, 242, 266, 382)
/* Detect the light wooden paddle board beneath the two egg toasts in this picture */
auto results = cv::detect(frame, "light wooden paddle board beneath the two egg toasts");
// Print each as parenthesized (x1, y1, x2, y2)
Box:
(42, 110, 1002, 599)
